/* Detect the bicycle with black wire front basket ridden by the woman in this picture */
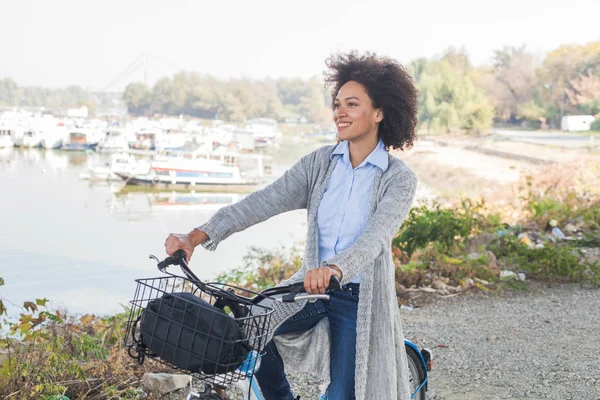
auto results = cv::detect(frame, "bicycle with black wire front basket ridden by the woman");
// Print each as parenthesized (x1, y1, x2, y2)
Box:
(125, 250, 432, 400)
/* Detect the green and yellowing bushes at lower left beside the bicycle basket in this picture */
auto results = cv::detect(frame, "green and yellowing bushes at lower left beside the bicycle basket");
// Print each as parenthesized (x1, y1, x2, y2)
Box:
(0, 278, 163, 400)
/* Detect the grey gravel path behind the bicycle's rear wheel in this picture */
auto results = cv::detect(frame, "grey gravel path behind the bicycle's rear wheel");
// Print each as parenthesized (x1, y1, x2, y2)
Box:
(164, 283, 600, 400)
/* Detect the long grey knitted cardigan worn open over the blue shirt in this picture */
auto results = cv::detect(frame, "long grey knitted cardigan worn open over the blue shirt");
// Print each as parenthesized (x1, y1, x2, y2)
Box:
(199, 146, 417, 400)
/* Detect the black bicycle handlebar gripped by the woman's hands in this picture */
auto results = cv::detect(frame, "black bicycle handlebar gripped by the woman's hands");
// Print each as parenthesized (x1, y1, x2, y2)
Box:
(150, 250, 341, 303)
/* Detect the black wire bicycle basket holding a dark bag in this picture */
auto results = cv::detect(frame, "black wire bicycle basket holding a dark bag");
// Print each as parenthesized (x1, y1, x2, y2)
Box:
(125, 277, 273, 384)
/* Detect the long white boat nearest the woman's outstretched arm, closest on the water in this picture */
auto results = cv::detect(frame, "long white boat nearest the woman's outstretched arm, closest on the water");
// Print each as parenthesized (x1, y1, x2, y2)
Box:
(116, 154, 263, 192)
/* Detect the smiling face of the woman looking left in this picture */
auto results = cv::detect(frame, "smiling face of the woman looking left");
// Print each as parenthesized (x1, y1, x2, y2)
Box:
(333, 81, 383, 141)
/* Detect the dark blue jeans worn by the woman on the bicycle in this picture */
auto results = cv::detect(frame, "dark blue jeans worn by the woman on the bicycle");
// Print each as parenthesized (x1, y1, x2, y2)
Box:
(255, 285, 358, 400)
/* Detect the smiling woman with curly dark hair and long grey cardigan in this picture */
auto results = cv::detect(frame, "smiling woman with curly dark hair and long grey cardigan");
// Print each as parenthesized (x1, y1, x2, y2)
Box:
(165, 52, 417, 400)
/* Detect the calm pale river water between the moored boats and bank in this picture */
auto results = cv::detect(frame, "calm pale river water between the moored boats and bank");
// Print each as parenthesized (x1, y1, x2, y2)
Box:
(0, 142, 432, 316)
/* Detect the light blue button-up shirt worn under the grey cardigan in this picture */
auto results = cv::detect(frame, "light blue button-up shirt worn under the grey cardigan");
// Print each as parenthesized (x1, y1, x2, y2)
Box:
(317, 139, 388, 283)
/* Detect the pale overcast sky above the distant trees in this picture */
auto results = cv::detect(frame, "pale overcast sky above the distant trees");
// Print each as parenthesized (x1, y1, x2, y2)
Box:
(0, 0, 600, 89)
